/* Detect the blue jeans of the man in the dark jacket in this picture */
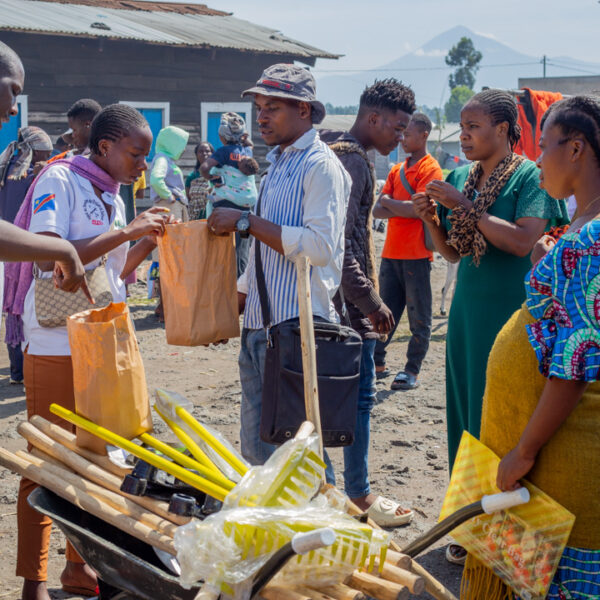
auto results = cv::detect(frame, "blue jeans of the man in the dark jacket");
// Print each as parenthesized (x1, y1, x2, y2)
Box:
(344, 340, 377, 498)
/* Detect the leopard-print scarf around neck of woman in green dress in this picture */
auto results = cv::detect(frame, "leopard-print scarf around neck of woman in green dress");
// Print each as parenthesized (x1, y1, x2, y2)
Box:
(446, 153, 525, 266)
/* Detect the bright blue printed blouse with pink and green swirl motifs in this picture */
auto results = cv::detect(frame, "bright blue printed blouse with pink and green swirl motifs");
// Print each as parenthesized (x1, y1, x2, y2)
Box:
(525, 220, 600, 381)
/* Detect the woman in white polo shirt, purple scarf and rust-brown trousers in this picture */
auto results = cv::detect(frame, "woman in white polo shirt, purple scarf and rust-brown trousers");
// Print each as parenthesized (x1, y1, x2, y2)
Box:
(12, 104, 168, 600)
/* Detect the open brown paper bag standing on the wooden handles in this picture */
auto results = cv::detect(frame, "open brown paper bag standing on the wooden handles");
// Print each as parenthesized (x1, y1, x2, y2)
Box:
(67, 302, 152, 454)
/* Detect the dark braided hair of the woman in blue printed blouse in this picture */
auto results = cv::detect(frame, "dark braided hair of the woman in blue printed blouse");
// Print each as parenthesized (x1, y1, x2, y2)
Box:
(540, 96, 600, 165)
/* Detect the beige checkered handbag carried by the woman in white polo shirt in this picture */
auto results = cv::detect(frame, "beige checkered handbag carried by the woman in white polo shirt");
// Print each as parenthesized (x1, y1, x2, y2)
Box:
(34, 256, 113, 327)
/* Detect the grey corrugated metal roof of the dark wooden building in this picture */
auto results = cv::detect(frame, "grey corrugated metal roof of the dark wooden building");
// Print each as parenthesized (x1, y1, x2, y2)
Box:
(0, 0, 340, 59)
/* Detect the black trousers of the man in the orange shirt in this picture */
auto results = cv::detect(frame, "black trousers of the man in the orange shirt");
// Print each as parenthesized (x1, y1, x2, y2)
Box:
(375, 258, 432, 375)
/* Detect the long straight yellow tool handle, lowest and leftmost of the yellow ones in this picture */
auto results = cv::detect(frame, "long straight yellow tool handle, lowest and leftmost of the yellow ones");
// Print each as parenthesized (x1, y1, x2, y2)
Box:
(50, 404, 229, 501)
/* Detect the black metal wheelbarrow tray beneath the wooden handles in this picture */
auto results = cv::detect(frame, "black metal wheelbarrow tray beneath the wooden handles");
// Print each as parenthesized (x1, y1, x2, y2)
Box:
(27, 487, 200, 600)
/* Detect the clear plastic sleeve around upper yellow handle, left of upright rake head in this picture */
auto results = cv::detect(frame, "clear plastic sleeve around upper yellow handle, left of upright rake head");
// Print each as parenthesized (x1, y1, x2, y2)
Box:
(155, 389, 249, 483)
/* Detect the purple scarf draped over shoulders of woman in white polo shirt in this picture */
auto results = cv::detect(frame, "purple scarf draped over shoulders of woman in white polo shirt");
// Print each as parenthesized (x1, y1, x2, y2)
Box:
(3, 156, 119, 345)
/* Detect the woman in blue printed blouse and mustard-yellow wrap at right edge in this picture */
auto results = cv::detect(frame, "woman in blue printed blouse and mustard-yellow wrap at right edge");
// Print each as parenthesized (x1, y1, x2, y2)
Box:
(461, 96, 600, 600)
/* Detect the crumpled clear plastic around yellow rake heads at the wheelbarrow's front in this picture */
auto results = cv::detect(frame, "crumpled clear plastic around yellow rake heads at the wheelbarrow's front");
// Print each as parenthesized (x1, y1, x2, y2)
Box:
(175, 497, 389, 600)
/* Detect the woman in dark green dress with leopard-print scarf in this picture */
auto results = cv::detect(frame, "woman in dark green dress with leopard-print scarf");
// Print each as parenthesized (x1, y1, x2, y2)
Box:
(413, 89, 566, 562)
